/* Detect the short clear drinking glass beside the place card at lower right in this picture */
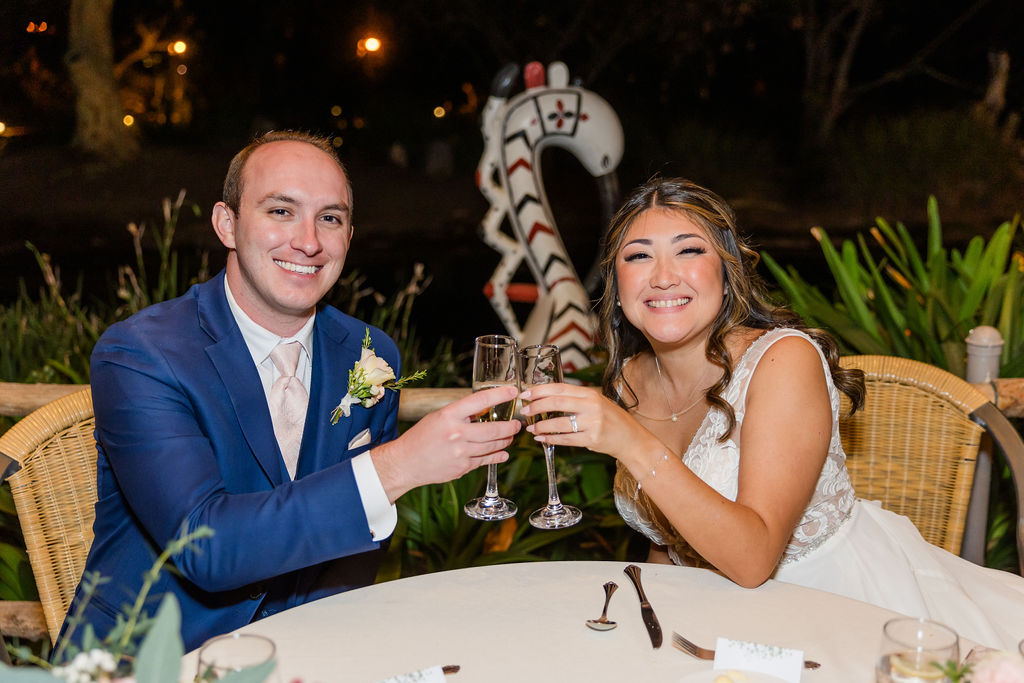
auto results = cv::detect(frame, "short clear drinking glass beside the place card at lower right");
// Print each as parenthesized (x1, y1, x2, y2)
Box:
(874, 616, 959, 683)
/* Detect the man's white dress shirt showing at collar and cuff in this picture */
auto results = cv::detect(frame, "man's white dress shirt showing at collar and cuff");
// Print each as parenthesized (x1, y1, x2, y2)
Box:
(224, 278, 398, 541)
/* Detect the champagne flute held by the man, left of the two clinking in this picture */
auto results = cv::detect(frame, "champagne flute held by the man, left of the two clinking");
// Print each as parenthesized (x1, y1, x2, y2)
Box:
(463, 335, 519, 521)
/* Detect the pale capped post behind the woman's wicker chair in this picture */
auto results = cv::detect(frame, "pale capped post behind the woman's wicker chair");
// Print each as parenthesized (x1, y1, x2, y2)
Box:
(961, 325, 1002, 564)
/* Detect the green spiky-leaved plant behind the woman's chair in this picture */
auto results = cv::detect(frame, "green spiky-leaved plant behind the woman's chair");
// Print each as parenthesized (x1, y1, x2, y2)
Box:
(762, 197, 1024, 377)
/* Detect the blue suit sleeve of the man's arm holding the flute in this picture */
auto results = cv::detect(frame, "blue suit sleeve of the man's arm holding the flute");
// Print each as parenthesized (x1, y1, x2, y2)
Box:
(91, 325, 387, 592)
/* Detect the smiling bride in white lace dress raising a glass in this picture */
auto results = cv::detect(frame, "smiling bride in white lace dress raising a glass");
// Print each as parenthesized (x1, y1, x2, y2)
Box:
(522, 179, 1024, 650)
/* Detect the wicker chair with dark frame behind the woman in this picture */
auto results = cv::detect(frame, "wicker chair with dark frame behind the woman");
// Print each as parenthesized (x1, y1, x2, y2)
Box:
(840, 355, 1024, 572)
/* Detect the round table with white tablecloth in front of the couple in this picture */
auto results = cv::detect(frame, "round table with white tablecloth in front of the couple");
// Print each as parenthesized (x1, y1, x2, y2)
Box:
(182, 562, 933, 683)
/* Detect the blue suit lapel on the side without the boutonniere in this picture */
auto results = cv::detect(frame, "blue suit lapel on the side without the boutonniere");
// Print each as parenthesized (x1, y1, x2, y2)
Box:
(199, 271, 288, 486)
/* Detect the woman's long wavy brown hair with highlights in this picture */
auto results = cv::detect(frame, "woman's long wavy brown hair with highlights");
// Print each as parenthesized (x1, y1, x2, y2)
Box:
(598, 178, 864, 440)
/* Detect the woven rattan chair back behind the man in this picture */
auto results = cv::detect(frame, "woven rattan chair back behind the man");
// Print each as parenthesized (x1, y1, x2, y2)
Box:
(0, 389, 96, 641)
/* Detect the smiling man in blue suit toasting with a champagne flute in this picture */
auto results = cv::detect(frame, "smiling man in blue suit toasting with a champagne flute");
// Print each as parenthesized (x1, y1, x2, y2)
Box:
(65, 132, 518, 649)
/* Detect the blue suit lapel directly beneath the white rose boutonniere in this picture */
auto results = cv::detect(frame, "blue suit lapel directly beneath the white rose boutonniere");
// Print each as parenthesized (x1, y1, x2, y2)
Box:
(296, 309, 356, 476)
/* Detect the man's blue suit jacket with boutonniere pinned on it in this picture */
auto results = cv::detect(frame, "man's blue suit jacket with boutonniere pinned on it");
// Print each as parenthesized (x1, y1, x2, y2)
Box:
(65, 272, 400, 649)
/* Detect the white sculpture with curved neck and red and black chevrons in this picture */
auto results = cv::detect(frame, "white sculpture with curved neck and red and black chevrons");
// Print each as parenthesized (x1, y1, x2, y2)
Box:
(476, 61, 623, 372)
